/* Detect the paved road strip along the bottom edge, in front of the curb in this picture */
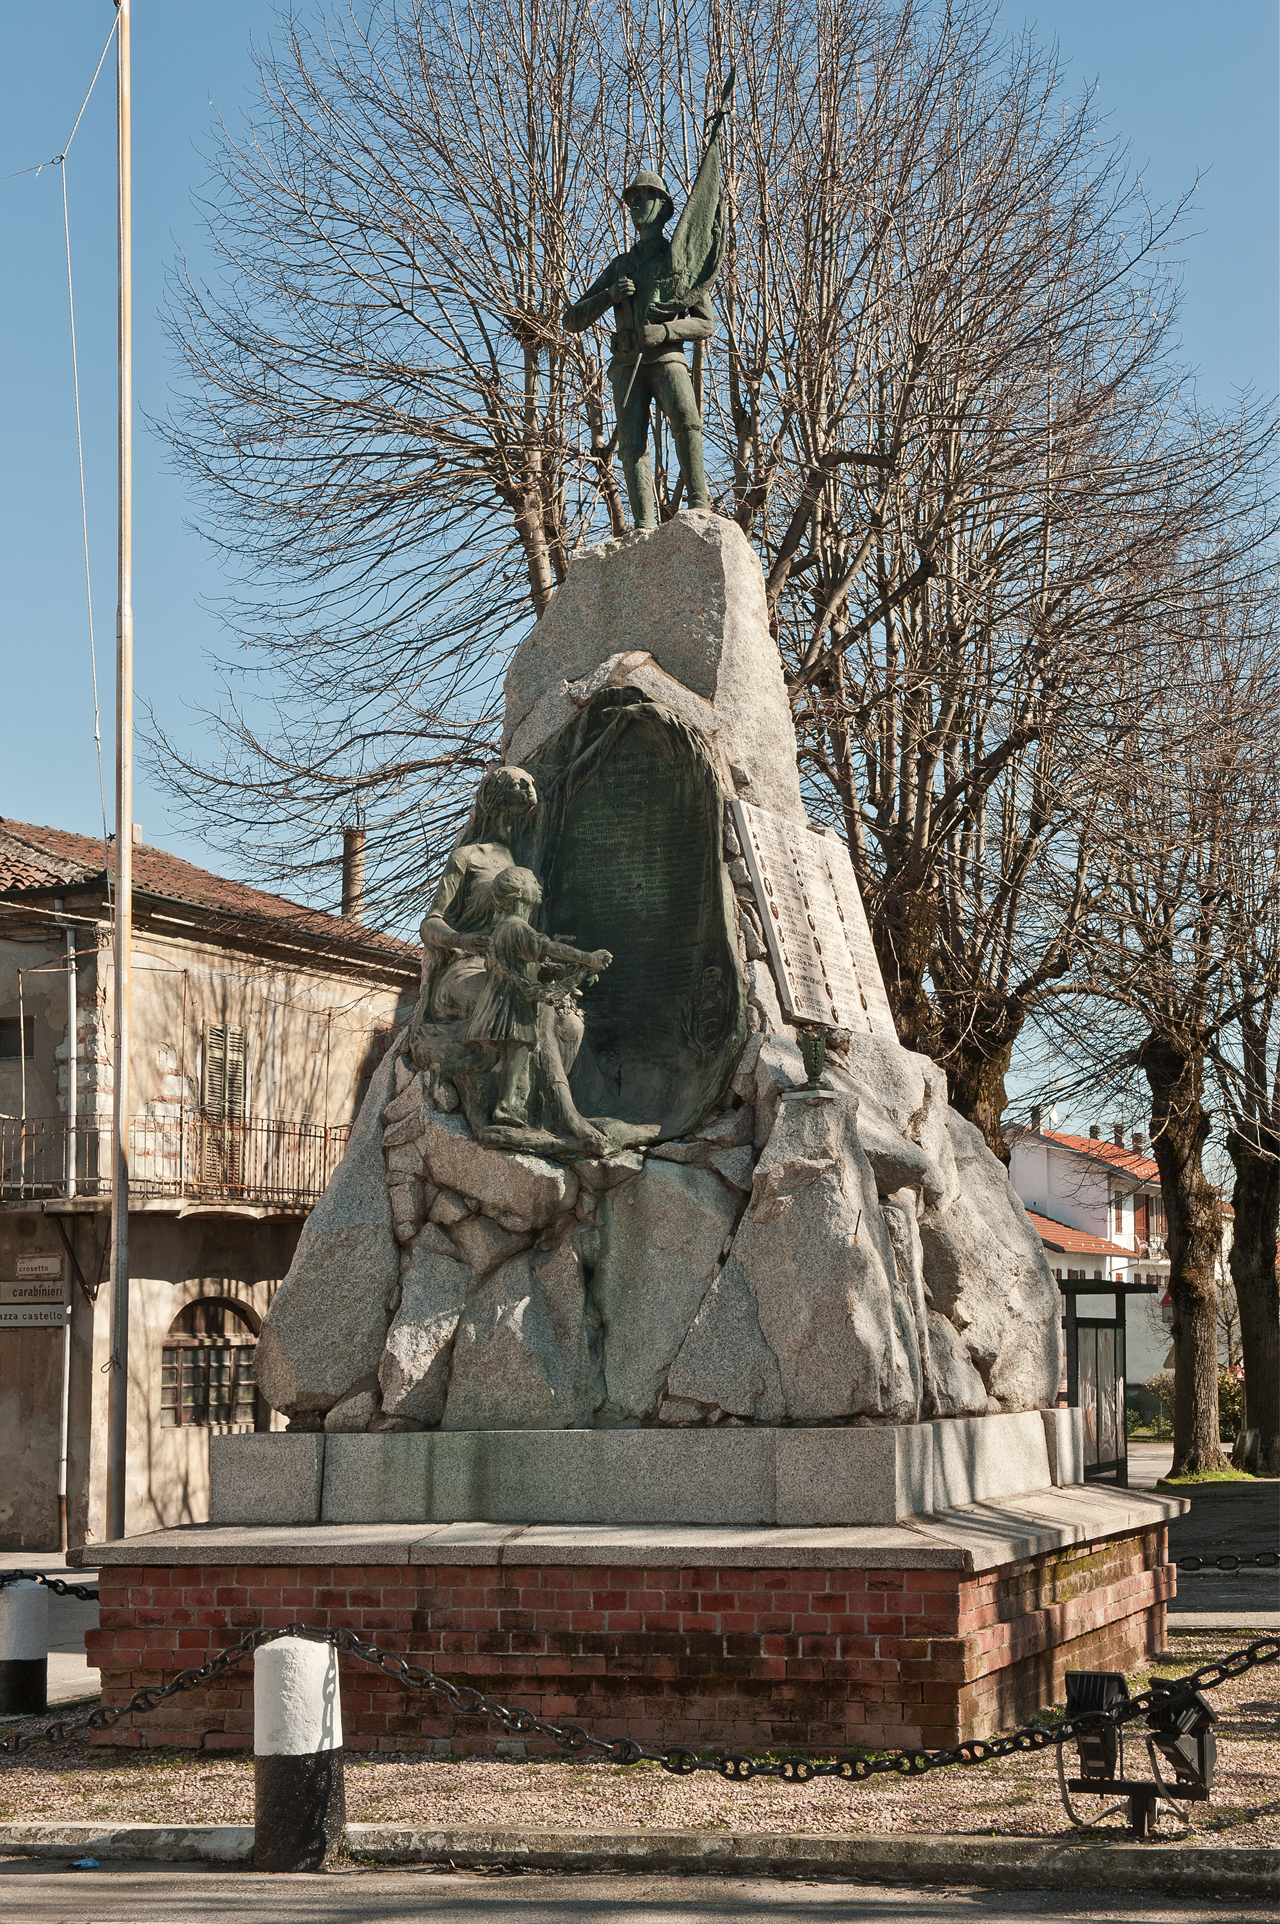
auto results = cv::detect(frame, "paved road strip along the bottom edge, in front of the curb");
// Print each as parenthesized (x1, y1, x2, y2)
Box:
(0, 1859, 1274, 1924)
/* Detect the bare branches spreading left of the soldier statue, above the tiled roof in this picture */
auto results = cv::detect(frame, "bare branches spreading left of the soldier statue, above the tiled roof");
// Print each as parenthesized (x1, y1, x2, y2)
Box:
(164, 0, 626, 900)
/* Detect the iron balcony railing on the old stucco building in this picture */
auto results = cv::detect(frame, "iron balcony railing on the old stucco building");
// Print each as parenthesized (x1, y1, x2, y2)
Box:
(0, 1110, 350, 1208)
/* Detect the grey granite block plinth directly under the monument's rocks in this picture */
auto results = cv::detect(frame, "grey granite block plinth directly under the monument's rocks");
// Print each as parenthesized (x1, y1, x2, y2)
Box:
(210, 1410, 1082, 1528)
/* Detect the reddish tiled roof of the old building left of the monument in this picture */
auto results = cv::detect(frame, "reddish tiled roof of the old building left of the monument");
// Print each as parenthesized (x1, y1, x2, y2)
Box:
(0, 816, 418, 964)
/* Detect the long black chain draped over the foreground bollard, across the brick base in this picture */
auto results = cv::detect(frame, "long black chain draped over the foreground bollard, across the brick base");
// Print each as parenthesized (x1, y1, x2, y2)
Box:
(0, 1624, 1280, 1784)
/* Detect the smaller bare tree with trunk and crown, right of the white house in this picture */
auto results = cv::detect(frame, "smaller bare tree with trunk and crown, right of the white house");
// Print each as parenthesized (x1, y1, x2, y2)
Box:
(1055, 554, 1276, 1472)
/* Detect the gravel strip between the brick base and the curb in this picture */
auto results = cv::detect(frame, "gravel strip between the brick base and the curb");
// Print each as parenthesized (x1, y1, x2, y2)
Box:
(0, 1633, 1280, 1847)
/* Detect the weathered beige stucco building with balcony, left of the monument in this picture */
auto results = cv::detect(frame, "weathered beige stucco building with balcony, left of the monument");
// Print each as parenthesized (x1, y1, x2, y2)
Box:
(0, 820, 420, 1549)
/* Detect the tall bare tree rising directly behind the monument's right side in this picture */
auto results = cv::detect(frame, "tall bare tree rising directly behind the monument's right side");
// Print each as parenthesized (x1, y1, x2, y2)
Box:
(735, 17, 1257, 1156)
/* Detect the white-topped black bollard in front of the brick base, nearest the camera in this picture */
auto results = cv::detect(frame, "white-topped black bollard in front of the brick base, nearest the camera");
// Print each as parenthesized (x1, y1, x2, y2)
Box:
(254, 1637, 346, 1870)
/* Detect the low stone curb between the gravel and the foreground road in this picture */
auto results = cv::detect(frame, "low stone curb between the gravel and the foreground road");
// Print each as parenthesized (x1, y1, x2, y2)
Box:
(0, 1824, 1280, 1897)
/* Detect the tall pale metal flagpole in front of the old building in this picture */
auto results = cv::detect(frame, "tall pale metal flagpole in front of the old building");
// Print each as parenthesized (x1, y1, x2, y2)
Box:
(106, 0, 133, 1541)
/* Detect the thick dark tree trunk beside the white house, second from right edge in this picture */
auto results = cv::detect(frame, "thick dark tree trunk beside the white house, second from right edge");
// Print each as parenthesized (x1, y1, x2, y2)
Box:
(1139, 1035, 1228, 1476)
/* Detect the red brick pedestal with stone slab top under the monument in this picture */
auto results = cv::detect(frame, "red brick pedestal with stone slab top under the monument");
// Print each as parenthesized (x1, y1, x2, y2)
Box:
(83, 1487, 1182, 1755)
